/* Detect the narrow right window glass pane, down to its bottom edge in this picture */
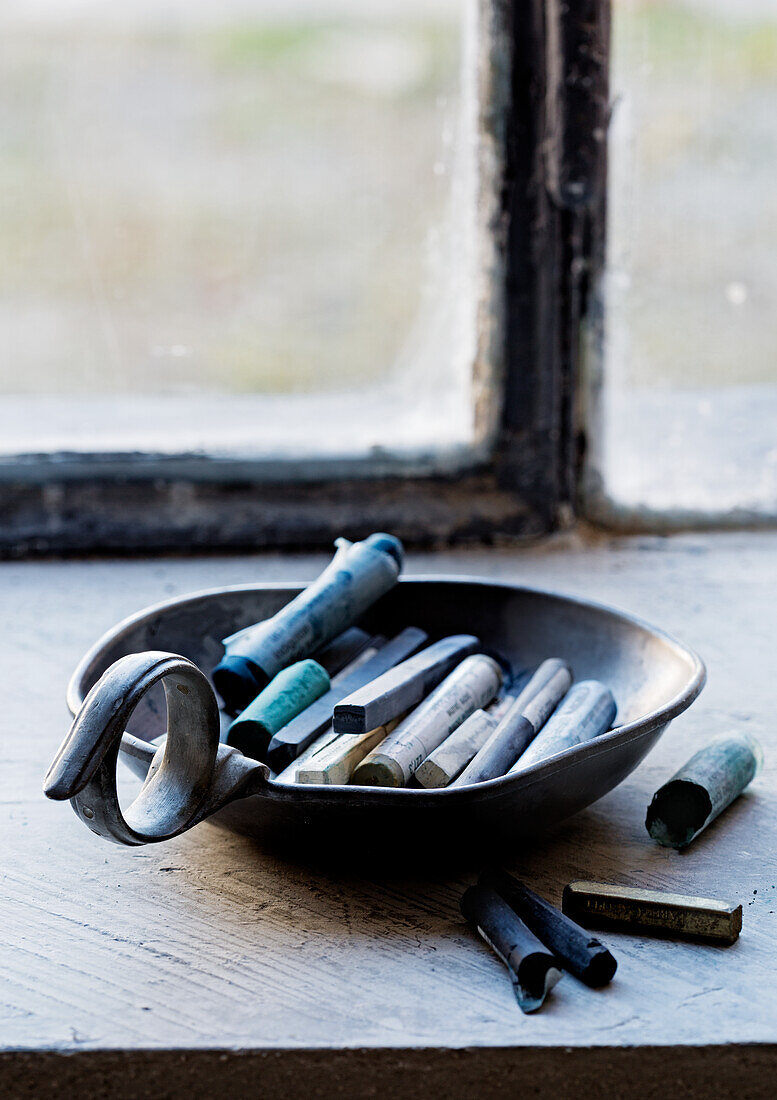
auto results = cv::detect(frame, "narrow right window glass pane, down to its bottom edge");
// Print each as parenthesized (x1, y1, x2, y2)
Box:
(594, 0, 777, 515)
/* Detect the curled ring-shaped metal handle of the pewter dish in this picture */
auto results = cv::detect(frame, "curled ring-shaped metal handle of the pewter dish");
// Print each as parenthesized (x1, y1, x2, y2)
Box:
(43, 650, 270, 845)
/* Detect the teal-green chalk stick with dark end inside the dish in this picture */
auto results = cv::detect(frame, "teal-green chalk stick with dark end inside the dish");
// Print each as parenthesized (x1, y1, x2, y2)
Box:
(227, 660, 329, 760)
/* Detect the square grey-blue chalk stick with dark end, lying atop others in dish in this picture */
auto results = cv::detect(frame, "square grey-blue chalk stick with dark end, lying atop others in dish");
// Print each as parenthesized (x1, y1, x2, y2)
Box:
(332, 634, 479, 734)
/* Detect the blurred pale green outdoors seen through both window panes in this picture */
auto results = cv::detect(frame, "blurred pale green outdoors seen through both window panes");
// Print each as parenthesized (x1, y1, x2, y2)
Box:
(0, 0, 777, 404)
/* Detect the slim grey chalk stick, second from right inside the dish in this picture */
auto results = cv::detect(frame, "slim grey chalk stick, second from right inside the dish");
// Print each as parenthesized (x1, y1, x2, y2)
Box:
(451, 658, 572, 787)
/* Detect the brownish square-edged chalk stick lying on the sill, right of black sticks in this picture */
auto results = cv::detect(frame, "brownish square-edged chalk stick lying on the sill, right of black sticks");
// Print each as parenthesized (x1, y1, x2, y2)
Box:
(561, 882, 742, 944)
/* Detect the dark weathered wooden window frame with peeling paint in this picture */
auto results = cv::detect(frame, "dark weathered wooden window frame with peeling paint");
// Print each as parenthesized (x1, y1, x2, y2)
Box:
(0, 0, 610, 557)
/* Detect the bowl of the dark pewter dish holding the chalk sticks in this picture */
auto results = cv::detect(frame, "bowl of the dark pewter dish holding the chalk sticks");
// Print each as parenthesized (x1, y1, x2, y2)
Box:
(60, 576, 705, 858)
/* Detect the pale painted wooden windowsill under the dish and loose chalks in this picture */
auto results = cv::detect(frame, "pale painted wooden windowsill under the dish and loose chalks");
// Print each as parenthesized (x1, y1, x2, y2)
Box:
(0, 531, 777, 1097)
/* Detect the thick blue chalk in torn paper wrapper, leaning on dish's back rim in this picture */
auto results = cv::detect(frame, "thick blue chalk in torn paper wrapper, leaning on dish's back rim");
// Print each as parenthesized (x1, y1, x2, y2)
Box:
(214, 534, 404, 713)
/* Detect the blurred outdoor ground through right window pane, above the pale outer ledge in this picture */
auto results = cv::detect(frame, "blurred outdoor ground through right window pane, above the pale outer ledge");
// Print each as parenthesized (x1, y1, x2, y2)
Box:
(606, 0, 777, 388)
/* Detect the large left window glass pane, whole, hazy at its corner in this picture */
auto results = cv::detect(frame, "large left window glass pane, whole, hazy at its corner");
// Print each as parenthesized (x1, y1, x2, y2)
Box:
(0, 0, 475, 454)
